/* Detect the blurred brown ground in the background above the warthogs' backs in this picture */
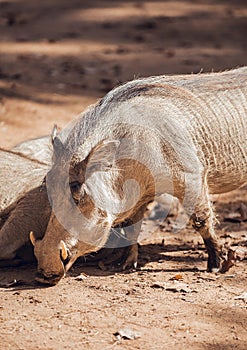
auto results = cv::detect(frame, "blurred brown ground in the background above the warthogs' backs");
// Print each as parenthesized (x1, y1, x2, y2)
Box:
(0, 0, 247, 148)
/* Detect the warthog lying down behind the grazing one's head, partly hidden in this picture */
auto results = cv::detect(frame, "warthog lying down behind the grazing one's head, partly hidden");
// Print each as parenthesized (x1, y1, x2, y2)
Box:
(0, 137, 52, 260)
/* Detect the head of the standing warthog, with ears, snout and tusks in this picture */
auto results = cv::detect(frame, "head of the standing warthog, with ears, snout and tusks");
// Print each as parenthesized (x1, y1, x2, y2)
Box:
(30, 131, 131, 285)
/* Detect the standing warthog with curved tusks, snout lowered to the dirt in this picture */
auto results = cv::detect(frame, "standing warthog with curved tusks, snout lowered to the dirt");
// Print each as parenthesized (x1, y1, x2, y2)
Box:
(31, 67, 247, 284)
